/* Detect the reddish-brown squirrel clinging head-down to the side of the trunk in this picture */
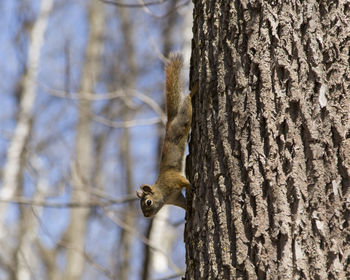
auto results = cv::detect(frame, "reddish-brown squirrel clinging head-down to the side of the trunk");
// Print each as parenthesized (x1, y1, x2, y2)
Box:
(136, 54, 197, 217)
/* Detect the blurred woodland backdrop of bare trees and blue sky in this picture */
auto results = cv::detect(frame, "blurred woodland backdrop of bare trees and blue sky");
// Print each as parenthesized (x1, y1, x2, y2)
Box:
(0, 0, 192, 279)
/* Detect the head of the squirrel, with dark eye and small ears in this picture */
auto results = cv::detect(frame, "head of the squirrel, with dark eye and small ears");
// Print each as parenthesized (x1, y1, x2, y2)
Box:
(136, 185, 164, 218)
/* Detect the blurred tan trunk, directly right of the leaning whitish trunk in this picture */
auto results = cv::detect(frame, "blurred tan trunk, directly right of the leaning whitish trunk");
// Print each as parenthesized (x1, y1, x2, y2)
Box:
(64, 1, 104, 280)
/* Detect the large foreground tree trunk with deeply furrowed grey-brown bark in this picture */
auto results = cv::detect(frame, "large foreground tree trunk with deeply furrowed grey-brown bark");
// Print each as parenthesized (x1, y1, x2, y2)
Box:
(185, 0, 350, 279)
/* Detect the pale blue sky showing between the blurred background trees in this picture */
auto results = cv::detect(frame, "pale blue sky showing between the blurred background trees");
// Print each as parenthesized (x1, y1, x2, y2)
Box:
(0, 0, 189, 279)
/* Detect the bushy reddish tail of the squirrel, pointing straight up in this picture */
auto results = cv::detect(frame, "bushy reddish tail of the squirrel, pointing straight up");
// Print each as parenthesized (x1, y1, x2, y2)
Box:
(165, 53, 183, 121)
